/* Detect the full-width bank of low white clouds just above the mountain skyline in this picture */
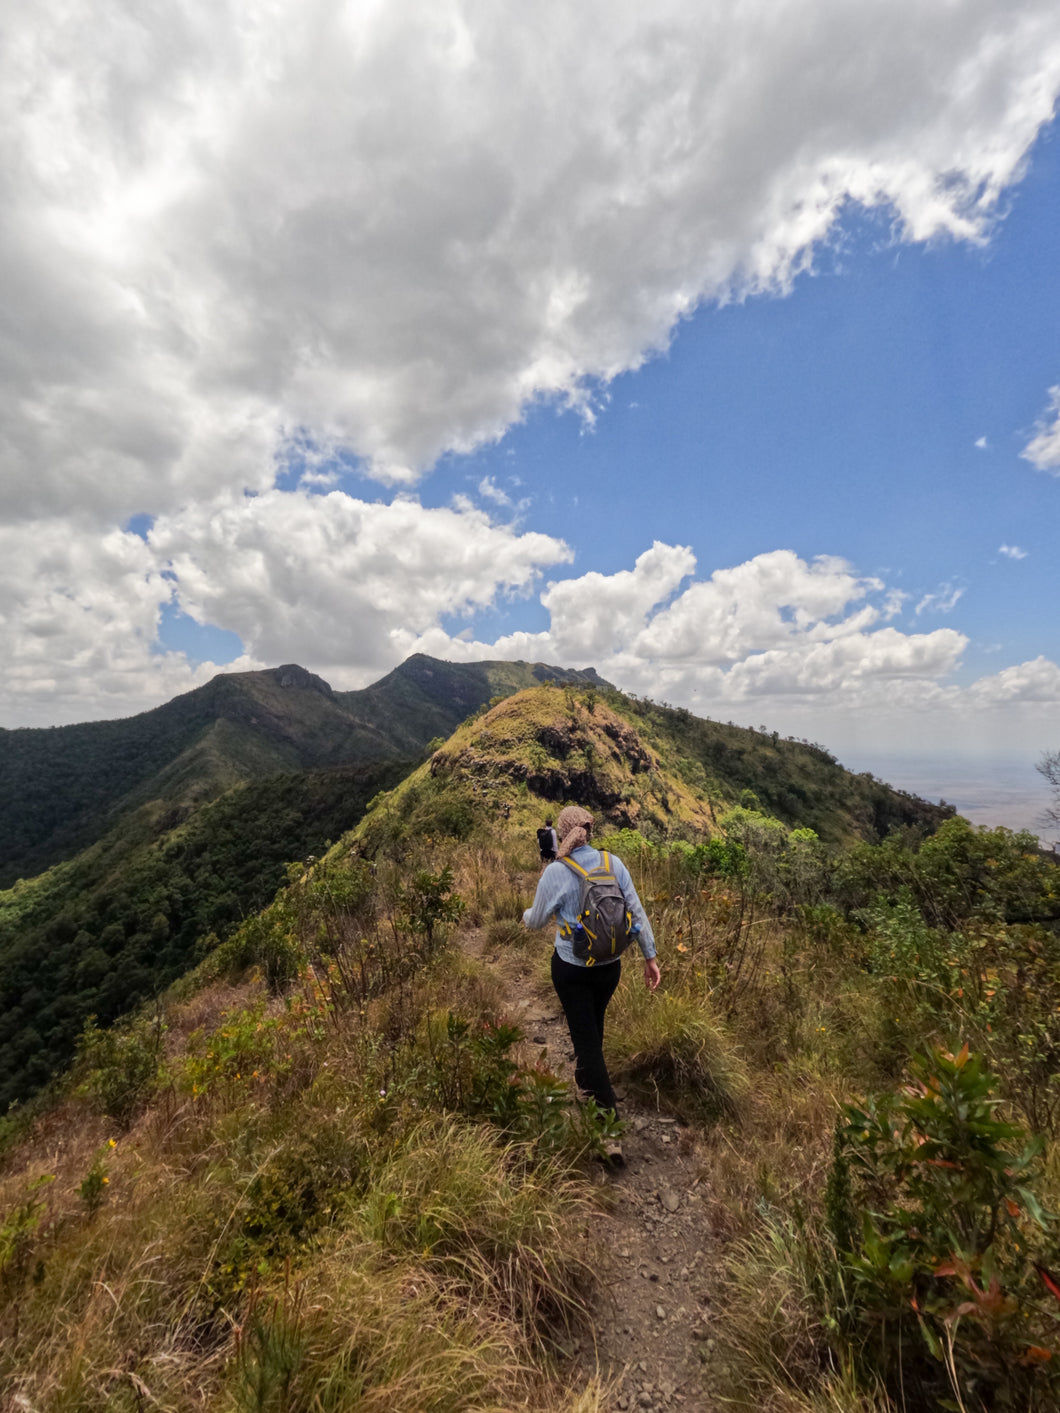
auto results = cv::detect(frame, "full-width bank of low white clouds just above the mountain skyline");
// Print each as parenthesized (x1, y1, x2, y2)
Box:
(8, 517, 1060, 749)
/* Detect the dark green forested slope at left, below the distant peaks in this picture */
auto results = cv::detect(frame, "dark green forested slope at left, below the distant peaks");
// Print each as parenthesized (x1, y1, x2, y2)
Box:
(0, 764, 403, 1112)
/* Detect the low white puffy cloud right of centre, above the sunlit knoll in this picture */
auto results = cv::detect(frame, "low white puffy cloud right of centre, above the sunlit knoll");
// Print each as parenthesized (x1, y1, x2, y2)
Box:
(401, 543, 968, 714)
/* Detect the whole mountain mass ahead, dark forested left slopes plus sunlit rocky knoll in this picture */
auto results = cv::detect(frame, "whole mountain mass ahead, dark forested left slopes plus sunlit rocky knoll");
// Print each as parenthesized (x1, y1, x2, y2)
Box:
(0, 656, 953, 1112)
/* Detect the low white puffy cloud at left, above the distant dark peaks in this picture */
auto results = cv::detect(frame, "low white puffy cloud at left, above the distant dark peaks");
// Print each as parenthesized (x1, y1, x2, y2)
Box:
(0, 490, 571, 725)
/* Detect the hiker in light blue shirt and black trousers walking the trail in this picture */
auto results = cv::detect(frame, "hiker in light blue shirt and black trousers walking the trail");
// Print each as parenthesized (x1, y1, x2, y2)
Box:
(523, 804, 659, 1163)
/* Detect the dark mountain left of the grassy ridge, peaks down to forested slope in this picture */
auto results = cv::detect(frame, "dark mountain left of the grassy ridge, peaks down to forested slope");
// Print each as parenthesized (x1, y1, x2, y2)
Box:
(0, 656, 606, 1112)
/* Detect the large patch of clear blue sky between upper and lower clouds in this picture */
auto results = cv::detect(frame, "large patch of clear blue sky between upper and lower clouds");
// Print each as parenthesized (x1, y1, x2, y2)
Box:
(409, 123, 1060, 681)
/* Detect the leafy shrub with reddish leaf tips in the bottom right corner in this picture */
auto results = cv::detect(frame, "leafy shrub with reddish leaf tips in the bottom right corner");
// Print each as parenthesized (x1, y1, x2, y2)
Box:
(827, 1046, 1060, 1410)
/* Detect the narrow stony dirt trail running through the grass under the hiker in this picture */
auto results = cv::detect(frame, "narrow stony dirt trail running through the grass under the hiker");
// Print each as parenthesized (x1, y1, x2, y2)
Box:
(464, 931, 714, 1413)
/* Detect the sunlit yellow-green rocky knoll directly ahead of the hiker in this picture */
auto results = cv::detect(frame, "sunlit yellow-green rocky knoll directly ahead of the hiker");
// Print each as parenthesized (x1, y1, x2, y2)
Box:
(354, 687, 954, 848)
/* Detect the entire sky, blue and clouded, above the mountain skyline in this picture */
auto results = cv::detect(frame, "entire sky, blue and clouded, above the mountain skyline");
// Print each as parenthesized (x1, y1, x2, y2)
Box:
(0, 0, 1060, 822)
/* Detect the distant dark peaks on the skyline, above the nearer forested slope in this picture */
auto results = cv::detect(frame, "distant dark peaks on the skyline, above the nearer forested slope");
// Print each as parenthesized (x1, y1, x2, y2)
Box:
(0, 654, 603, 887)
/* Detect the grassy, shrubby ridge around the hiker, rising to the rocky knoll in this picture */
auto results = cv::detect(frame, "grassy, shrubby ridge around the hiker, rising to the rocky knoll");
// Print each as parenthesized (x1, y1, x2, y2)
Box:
(0, 688, 1060, 1413)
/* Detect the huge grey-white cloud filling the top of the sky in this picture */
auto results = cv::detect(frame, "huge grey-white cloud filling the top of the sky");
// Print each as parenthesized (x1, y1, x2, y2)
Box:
(0, 0, 1060, 523)
